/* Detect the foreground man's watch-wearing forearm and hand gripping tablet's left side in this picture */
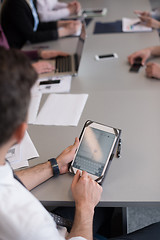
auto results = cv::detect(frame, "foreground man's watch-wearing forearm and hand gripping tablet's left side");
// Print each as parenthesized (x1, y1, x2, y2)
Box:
(15, 138, 79, 190)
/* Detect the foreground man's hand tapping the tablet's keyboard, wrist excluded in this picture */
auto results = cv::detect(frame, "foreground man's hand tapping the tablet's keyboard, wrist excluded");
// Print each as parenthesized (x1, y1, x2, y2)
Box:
(71, 171, 102, 211)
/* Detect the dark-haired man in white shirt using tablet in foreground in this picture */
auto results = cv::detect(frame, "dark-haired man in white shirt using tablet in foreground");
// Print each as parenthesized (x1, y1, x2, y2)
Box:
(0, 48, 102, 240)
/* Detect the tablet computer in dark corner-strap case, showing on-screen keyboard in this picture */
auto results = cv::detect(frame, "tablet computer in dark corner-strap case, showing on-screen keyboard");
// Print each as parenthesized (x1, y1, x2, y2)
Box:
(69, 120, 121, 183)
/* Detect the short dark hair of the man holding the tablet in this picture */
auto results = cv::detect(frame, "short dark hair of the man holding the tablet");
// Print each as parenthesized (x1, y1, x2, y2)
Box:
(0, 47, 37, 145)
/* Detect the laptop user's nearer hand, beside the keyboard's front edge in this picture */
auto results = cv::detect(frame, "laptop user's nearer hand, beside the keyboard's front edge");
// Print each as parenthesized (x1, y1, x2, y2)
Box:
(32, 61, 54, 74)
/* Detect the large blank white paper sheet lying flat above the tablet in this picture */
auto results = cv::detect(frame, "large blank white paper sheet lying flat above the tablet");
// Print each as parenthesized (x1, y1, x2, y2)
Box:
(35, 94, 88, 126)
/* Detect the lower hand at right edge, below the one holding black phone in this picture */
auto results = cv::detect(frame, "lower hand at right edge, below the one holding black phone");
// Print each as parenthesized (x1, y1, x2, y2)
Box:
(146, 62, 160, 79)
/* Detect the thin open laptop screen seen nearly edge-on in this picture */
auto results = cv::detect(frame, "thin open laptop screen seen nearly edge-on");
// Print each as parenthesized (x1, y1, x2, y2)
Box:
(76, 21, 86, 67)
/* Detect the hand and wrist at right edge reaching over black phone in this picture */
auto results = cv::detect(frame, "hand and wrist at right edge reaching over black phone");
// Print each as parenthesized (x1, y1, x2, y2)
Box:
(128, 46, 160, 65)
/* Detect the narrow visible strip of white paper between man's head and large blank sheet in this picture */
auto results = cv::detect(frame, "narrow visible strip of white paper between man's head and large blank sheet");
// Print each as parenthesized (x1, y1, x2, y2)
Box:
(28, 91, 42, 124)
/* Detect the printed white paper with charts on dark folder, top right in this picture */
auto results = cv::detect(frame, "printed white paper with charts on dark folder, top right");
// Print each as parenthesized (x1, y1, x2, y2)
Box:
(122, 18, 152, 32)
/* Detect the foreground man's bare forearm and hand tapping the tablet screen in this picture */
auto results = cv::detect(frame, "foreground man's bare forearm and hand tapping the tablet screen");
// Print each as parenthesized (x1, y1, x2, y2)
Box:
(67, 171, 102, 240)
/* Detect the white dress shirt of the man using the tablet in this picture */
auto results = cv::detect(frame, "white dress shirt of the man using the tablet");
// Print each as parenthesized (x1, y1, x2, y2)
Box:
(0, 163, 84, 240)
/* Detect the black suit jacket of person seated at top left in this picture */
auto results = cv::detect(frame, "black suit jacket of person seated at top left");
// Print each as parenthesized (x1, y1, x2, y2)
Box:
(1, 0, 58, 48)
